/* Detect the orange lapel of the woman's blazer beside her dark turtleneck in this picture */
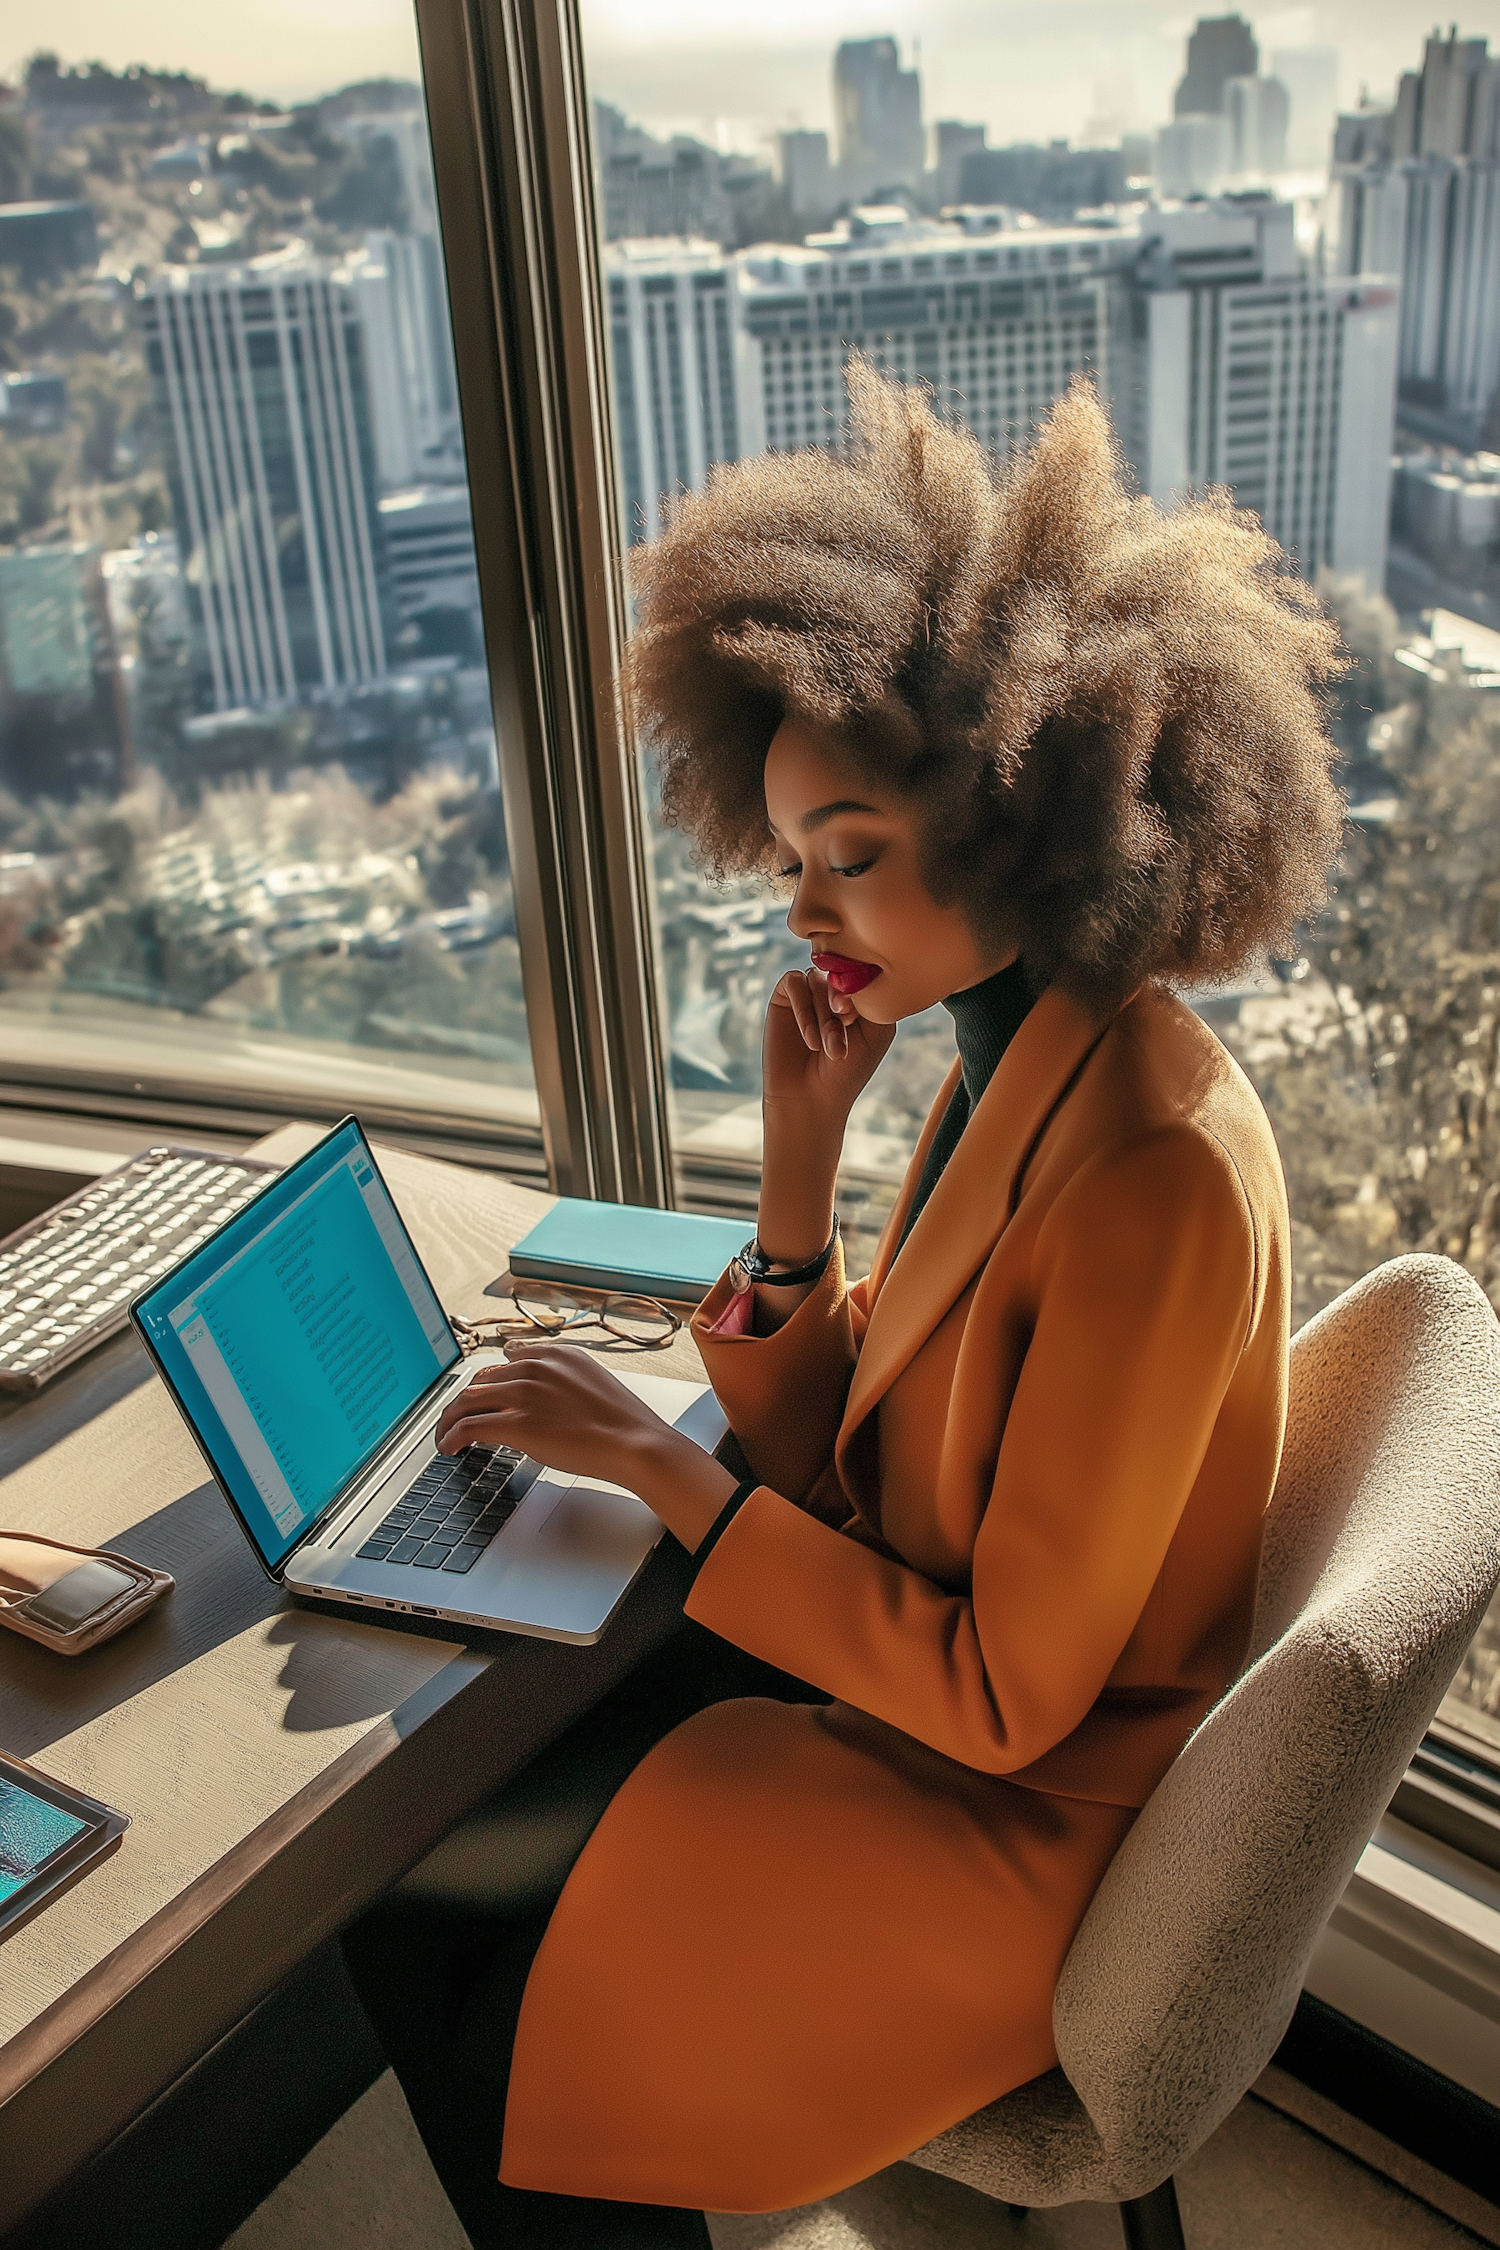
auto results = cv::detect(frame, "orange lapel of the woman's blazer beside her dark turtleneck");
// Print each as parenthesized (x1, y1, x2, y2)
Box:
(837, 986, 1113, 1458)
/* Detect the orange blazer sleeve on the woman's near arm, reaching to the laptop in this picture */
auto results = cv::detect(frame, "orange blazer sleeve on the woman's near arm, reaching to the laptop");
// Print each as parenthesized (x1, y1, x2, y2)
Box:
(686, 1125, 1255, 1773)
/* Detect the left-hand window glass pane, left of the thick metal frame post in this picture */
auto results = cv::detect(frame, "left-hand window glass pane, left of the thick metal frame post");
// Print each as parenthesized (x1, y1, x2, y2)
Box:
(0, 17, 537, 1136)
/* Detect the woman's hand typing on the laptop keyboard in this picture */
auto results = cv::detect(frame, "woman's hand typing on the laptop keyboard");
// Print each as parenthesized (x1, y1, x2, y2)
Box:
(436, 1343, 735, 1550)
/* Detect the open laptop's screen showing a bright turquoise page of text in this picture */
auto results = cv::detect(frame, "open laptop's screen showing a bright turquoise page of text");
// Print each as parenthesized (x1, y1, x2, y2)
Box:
(130, 1118, 459, 1571)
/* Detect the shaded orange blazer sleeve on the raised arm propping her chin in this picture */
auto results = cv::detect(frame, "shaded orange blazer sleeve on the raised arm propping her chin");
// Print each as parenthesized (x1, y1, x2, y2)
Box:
(693, 1240, 864, 1501)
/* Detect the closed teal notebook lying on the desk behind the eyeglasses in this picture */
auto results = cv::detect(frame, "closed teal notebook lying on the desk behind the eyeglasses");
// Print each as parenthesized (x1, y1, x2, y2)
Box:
(510, 1195, 756, 1305)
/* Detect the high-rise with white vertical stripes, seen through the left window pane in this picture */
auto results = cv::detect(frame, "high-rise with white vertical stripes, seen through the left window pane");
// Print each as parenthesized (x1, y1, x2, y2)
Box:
(139, 243, 387, 711)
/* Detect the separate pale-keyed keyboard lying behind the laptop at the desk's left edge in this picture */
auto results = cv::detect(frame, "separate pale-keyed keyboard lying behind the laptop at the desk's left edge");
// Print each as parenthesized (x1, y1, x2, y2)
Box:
(0, 1145, 279, 1391)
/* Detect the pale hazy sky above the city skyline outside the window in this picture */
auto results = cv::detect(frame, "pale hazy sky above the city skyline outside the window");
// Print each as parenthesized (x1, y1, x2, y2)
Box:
(14, 0, 1500, 146)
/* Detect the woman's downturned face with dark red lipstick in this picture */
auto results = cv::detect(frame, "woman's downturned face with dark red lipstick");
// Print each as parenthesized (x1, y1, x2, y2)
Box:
(765, 720, 1014, 1024)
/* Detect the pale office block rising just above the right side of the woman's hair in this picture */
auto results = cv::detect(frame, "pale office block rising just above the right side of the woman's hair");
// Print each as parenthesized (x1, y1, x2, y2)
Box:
(1113, 196, 1399, 592)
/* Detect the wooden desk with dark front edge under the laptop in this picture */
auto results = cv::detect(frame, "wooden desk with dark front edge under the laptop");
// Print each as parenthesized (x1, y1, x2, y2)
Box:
(0, 1125, 704, 2237)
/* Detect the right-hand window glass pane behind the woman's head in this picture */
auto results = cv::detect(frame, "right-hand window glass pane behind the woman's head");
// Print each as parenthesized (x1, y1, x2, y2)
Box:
(582, 0, 1500, 1753)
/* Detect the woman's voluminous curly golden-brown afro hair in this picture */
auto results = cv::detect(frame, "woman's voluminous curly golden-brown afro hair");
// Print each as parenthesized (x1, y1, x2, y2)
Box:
(625, 360, 1345, 995)
